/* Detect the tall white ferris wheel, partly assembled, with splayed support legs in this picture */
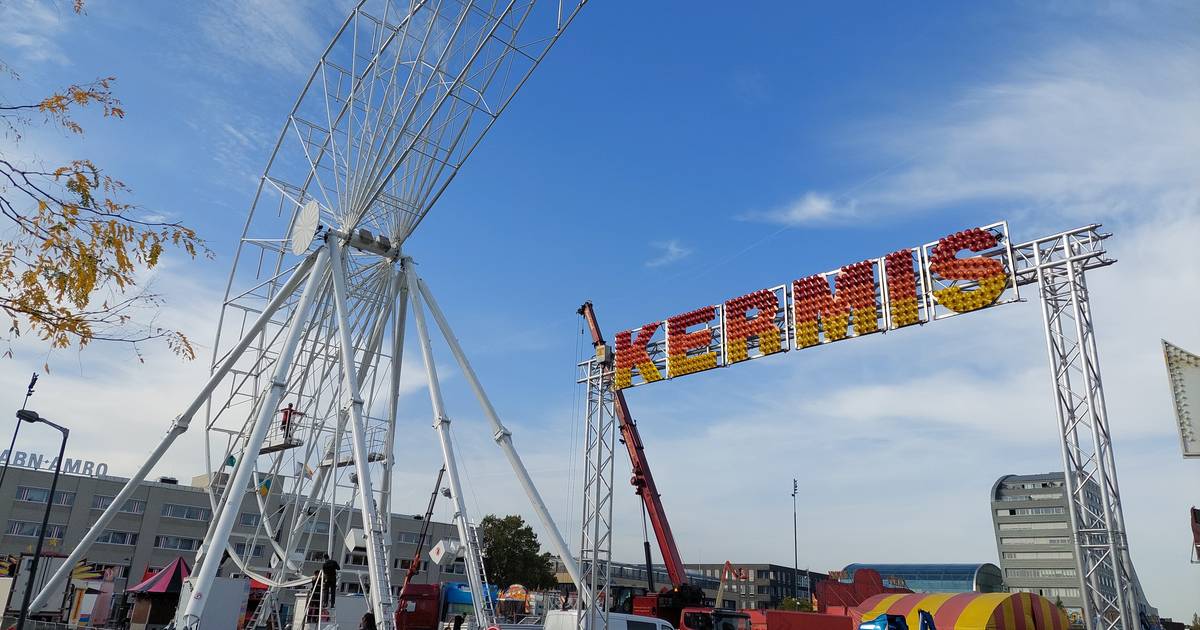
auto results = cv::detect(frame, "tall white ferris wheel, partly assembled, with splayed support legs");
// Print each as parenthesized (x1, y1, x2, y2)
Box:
(31, 0, 586, 628)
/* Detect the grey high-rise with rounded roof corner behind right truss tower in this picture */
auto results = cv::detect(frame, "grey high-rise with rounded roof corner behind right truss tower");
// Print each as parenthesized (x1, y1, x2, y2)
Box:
(991, 473, 1115, 622)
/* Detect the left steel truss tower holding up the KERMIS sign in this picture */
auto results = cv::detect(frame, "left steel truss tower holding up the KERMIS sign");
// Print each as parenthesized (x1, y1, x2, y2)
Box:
(575, 346, 617, 630)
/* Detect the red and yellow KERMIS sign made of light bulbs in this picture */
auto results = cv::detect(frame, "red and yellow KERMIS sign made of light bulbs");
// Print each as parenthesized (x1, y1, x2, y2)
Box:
(613, 221, 1019, 389)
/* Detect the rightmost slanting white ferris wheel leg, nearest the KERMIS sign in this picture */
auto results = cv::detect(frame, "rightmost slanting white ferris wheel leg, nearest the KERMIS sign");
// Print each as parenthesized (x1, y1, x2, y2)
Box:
(416, 270, 587, 596)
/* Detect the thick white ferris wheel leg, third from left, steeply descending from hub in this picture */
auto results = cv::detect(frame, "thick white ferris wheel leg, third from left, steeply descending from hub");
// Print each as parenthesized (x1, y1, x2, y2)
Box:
(326, 235, 394, 630)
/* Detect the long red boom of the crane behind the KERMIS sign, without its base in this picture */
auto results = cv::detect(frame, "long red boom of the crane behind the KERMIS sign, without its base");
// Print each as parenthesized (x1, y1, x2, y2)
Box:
(578, 301, 688, 588)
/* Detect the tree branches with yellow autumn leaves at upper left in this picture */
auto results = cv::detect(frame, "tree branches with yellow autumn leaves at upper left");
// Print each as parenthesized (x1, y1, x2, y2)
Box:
(0, 0, 209, 359)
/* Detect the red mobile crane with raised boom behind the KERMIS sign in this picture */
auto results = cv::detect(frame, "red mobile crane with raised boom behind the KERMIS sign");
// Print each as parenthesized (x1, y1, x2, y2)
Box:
(578, 301, 750, 630)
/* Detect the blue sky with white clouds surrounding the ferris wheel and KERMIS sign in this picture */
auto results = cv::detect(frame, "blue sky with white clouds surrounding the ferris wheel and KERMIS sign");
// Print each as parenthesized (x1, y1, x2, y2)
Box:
(0, 0, 1200, 619)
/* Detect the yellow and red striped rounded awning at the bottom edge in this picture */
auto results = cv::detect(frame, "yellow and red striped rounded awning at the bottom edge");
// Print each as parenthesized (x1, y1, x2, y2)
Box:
(854, 593, 1067, 630)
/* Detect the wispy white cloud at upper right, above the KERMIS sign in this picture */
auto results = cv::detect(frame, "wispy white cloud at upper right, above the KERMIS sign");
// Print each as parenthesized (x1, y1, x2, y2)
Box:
(858, 40, 1200, 216)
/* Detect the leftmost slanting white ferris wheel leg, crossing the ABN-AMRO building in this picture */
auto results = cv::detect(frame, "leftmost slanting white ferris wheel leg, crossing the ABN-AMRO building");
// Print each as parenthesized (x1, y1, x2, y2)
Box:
(30, 256, 314, 611)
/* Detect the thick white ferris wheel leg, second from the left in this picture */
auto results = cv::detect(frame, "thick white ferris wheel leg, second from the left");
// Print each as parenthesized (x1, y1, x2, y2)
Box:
(182, 250, 329, 629)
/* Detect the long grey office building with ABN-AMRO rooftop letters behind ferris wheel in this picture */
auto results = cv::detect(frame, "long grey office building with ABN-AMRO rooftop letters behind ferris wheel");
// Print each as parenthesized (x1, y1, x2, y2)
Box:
(0, 462, 466, 609)
